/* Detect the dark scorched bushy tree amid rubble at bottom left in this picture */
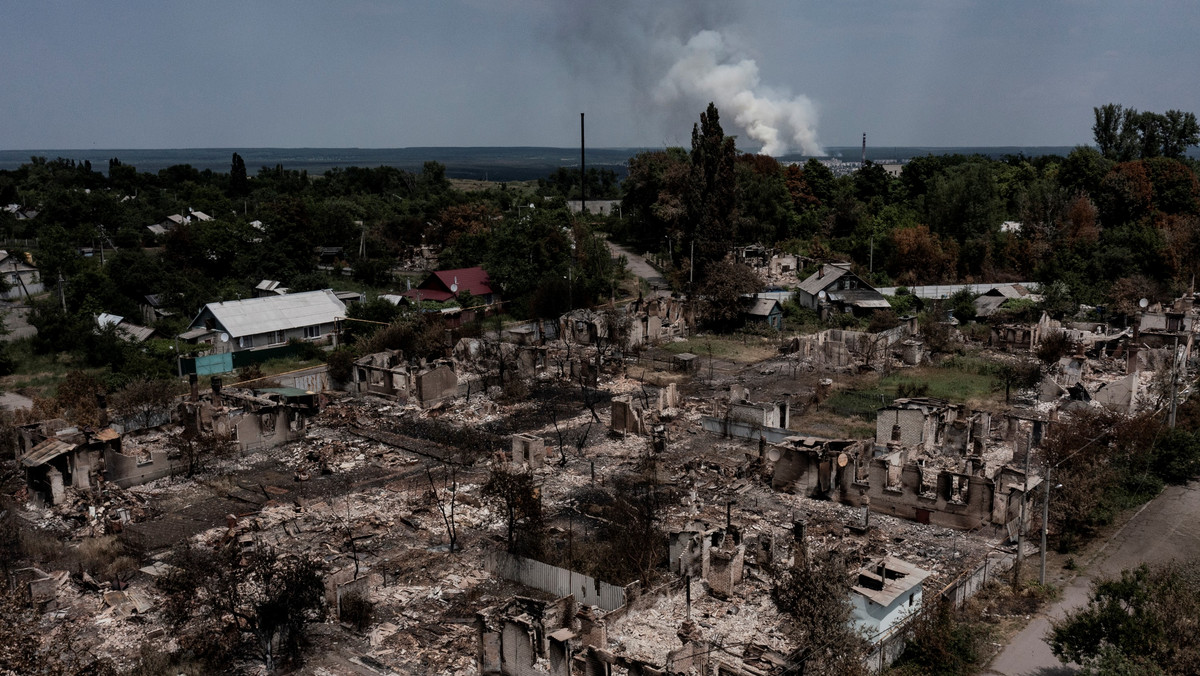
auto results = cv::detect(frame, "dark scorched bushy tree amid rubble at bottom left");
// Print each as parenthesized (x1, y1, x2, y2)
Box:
(158, 545, 325, 672)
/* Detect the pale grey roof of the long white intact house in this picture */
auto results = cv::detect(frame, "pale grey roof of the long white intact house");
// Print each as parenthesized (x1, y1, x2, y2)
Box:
(192, 288, 346, 337)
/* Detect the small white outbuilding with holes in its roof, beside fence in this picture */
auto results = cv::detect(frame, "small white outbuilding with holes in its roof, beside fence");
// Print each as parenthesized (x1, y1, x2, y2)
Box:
(850, 556, 930, 640)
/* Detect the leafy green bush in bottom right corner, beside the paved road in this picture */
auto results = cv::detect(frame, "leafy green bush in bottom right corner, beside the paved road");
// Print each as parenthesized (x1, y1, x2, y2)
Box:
(1046, 561, 1200, 675)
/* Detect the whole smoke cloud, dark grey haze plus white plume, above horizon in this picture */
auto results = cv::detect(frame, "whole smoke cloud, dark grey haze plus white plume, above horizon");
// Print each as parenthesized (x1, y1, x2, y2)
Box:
(547, 0, 823, 156)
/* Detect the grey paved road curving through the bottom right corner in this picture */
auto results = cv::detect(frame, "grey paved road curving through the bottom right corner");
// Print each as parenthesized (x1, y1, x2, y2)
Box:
(984, 481, 1200, 676)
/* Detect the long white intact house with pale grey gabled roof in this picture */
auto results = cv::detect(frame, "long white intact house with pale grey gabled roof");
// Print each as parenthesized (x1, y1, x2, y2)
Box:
(179, 289, 346, 353)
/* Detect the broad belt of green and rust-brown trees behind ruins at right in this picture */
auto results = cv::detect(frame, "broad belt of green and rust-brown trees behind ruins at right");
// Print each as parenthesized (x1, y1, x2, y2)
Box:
(617, 104, 1200, 312)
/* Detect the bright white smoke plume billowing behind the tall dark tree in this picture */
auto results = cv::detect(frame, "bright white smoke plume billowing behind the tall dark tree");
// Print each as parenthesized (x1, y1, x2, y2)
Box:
(655, 30, 823, 156)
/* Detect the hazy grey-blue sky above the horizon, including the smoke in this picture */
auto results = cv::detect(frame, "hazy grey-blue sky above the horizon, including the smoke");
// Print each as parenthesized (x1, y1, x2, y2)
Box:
(0, 0, 1200, 154)
